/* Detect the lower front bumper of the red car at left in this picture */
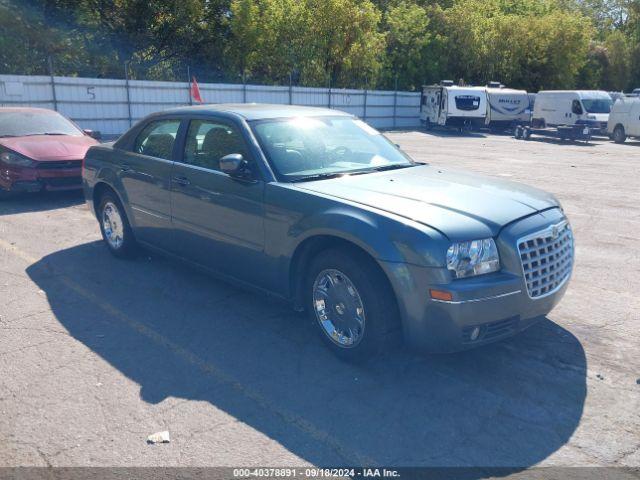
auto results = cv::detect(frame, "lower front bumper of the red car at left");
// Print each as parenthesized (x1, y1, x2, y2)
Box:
(0, 165, 82, 192)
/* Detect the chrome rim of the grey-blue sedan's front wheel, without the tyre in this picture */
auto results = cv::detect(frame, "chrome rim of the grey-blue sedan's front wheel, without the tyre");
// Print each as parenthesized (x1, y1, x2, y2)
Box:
(313, 269, 366, 348)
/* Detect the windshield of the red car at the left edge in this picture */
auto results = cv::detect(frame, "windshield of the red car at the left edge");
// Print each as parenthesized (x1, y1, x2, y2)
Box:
(0, 111, 83, 137)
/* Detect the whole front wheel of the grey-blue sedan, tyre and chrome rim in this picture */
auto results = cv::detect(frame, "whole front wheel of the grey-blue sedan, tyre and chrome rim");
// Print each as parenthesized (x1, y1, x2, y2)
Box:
(305, 249, 399, 361)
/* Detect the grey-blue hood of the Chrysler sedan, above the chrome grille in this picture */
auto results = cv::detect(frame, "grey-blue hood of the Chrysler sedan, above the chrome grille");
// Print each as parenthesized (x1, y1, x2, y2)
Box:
(296, 165, 558, 240)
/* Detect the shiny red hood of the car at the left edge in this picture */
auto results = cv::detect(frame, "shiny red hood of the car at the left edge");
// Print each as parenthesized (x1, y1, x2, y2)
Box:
(0, 135, 98, 160)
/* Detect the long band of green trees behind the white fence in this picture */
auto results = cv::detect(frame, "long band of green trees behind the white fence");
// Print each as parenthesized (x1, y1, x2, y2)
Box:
(0, 0, 640, 91)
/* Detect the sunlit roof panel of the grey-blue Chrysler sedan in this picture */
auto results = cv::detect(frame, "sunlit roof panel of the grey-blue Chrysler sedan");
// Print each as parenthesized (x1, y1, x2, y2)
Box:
(161, 103, 352, 120)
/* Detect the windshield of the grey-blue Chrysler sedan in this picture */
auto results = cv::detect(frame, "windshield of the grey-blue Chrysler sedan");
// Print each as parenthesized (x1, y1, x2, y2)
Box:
(252, 117, 414, 181)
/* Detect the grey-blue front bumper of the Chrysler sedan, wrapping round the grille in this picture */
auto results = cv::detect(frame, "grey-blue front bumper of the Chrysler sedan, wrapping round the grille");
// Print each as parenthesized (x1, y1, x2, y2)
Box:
(384, 209, 570, 352)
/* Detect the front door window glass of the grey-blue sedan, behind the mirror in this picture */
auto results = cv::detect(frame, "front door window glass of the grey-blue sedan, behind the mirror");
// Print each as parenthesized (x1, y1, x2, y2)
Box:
(184, 120, 249, 170)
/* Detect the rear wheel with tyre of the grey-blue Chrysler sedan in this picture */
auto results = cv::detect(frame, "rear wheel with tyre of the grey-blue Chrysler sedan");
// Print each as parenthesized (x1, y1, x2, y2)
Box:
(98, 192, 136, 258)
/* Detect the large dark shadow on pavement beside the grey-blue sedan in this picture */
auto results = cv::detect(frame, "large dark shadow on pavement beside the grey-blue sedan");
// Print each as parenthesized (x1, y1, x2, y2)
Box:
(27, 242, 586, 470)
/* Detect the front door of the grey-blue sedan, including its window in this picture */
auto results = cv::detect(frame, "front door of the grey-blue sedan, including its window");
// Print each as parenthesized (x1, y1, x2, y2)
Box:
(171, 117, 265, 285)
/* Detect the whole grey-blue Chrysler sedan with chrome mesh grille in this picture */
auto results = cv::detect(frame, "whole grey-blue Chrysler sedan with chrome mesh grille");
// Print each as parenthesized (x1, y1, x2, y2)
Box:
(83, 104, 573, 359)
